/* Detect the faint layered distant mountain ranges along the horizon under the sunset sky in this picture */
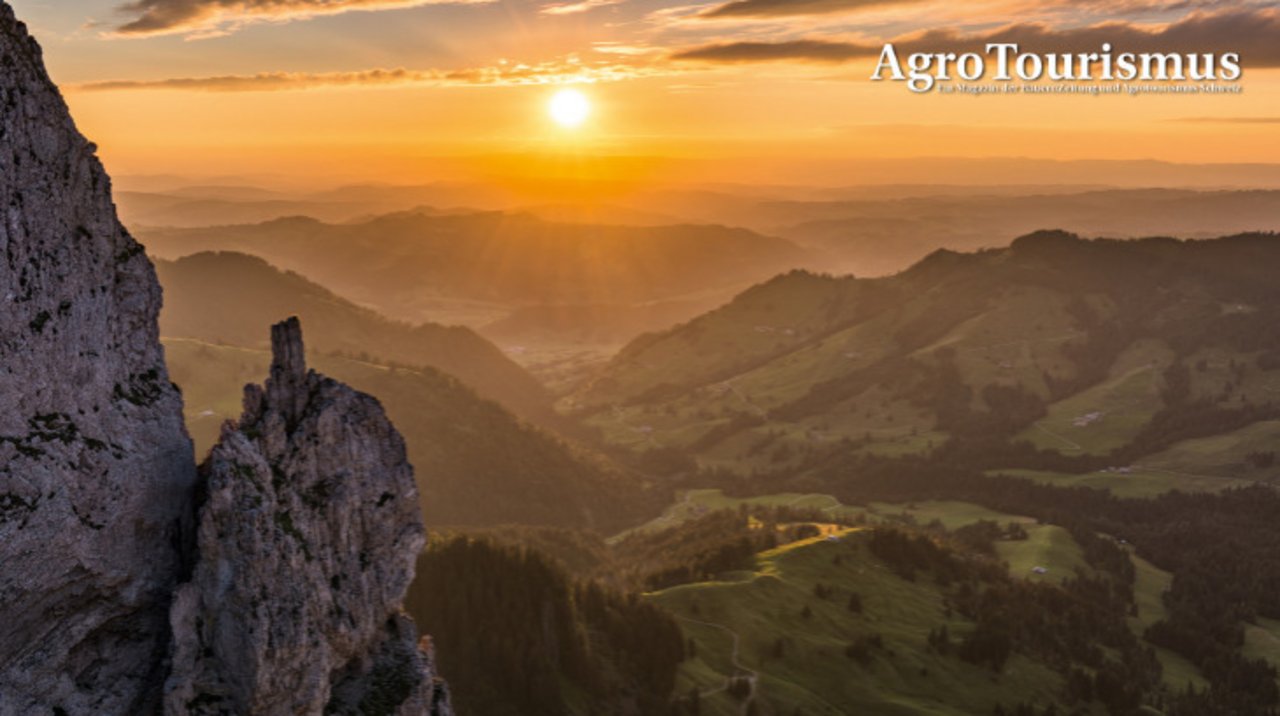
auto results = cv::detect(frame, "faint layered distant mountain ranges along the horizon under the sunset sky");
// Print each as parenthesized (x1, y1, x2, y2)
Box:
(120, 182, 1280, 299)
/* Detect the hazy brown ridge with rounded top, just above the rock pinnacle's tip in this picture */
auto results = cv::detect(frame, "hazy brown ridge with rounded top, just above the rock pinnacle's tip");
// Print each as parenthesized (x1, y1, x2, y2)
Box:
(156, 252, 548, 416)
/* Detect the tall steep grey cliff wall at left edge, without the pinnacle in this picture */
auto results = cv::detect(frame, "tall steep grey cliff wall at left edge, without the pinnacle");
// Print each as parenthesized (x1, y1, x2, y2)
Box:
(0, 3, 196, 715)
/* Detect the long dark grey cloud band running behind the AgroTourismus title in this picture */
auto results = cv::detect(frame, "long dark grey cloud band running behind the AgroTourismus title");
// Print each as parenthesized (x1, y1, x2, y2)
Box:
(672, 8, 1280, 70)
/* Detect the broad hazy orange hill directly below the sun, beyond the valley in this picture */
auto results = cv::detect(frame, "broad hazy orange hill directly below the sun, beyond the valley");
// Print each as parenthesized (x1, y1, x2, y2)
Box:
(132, 211, 806, 321)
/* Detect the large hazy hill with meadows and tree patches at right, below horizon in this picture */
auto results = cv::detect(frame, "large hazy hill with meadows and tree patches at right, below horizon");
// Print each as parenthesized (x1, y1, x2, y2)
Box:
(576, 232, 1280, 484)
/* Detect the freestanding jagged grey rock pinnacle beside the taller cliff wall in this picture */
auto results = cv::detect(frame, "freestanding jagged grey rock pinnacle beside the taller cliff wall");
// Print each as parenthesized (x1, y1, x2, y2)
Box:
(165, 319, 448, 715)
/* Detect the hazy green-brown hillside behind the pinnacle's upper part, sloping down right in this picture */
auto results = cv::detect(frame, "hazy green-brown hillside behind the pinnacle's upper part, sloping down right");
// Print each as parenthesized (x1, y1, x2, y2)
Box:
(165, 333, 664, 532)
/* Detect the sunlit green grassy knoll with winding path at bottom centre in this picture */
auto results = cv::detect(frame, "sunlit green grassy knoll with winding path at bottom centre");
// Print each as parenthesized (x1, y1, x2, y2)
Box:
(650, 530, 1061, 716)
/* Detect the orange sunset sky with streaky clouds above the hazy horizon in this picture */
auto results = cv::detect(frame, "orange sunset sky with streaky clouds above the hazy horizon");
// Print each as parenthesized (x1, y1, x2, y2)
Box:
(10, 0, 1280, 183)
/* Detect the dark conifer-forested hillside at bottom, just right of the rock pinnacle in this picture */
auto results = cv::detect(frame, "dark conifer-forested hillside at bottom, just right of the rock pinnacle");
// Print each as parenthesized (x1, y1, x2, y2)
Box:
(406, 537, 685, 716)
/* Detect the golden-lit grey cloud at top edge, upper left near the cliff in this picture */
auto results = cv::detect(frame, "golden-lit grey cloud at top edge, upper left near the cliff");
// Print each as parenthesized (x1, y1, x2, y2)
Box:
(113, 0, 488, 38)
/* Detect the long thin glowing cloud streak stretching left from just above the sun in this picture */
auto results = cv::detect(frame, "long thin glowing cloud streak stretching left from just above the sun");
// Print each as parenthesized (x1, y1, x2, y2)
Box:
(72, 60, 666, 92)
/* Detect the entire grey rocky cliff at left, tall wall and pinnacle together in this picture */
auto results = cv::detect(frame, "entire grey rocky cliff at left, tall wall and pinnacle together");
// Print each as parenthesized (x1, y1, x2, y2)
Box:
(0, 0, 448, 716)
